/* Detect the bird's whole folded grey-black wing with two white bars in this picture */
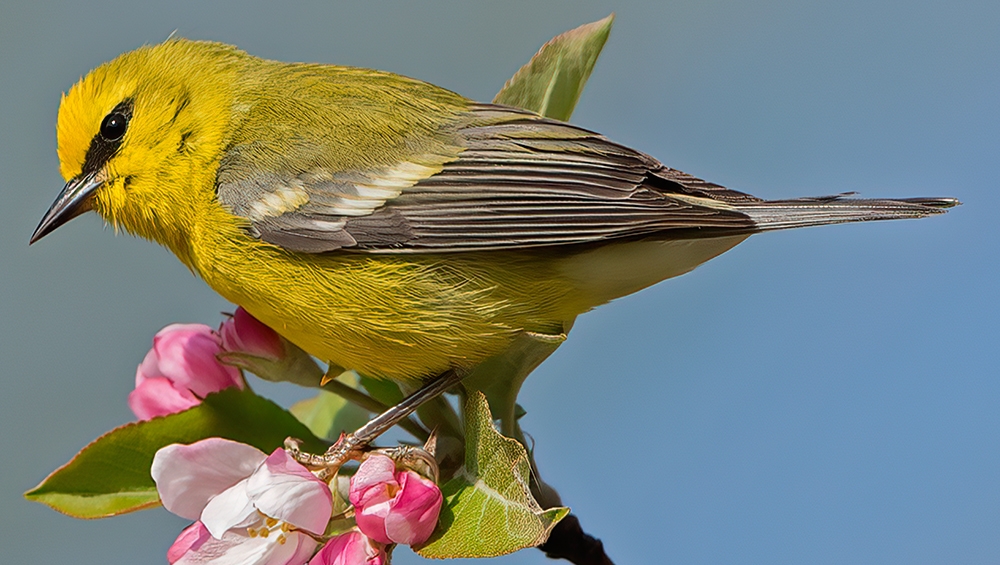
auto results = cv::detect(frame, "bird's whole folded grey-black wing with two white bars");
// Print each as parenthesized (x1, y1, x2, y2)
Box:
(217, 104, 928, 253)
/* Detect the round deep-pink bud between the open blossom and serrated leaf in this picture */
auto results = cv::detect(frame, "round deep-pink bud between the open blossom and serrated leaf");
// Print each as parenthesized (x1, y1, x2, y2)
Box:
(350, 453, 443, 545)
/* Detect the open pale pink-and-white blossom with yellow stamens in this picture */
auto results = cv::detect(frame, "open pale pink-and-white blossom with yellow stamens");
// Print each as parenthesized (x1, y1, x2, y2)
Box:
(151, 438, 333, 565)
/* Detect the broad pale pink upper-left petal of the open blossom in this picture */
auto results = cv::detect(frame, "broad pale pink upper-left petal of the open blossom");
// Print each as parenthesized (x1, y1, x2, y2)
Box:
(150, 438, 267, 520)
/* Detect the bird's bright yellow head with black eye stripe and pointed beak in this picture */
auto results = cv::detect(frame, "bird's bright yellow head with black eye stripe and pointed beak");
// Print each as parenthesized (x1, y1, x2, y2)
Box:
(31, 39, 246, 259)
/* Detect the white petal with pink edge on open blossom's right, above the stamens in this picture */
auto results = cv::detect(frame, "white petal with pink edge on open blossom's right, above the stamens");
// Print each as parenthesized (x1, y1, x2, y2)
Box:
(247, 448, 333, 534)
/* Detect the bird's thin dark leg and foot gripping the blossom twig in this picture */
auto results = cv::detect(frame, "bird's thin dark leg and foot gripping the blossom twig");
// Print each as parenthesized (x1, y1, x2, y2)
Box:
(285, 369, 468, 479)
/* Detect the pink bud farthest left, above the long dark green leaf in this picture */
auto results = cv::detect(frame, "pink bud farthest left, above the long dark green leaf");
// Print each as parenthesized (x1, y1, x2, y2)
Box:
(128, 324, 243, 420)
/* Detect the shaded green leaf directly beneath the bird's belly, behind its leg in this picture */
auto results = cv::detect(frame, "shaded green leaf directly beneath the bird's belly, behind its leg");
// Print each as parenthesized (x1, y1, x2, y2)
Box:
(462, 332, 566, 437)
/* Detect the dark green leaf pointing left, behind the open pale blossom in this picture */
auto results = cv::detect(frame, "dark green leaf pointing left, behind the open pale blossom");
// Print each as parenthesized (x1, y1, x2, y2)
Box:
(24, 388, 327, 518)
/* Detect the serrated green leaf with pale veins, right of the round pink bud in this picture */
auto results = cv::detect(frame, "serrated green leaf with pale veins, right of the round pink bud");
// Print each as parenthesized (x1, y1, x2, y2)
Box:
(414, 392, 569, 559)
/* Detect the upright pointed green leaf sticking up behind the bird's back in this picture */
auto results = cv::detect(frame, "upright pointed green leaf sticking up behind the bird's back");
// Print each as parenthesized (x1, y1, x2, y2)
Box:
(493, 14, 615, 121)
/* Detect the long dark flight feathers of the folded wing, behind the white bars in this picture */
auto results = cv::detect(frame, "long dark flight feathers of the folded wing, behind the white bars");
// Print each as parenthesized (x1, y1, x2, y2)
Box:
(345, 105, 756, 252)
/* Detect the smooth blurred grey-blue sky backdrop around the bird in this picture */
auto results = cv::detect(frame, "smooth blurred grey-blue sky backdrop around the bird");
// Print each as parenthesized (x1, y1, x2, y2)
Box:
(0, 0, 1000, 565)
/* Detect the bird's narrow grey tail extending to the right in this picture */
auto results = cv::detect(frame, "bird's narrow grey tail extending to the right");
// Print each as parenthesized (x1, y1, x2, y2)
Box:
(736, 193, 961, 231)
